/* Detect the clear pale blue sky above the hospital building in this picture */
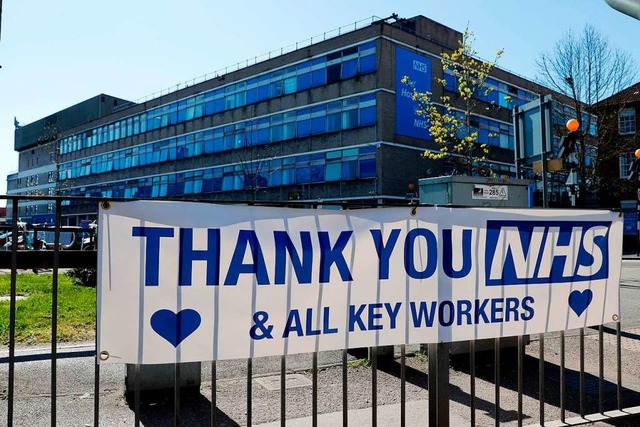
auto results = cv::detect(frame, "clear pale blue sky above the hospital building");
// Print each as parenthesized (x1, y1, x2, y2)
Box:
(0, 0, 640, 198)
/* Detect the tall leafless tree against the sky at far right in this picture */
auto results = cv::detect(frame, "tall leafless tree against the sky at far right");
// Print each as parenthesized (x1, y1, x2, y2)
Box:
(536, 24, 636, 206)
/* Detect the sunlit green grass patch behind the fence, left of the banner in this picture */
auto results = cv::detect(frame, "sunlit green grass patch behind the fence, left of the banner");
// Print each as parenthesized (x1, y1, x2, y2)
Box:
(0, 274, 96, 346)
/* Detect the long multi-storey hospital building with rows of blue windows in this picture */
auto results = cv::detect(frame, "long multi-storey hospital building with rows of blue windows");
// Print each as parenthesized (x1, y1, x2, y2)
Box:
(8, 16, 568, 223)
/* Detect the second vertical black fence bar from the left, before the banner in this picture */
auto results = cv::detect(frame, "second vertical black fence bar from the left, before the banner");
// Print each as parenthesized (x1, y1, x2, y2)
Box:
(50, 199, 62, 426)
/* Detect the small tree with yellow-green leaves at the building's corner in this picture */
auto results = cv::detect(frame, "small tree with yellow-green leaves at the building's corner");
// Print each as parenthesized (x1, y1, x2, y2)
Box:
(403, 28, 503, 176)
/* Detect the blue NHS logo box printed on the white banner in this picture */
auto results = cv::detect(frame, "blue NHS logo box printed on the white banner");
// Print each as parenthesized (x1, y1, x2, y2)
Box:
(485, 221, 611, 286)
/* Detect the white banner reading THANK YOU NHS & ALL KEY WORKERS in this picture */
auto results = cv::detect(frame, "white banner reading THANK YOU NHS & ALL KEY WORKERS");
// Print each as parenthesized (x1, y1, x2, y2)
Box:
(98, 201, 622, 363)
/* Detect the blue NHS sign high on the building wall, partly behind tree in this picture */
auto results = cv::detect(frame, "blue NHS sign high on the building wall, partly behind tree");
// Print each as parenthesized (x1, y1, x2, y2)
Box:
(396, 47, 431, 139)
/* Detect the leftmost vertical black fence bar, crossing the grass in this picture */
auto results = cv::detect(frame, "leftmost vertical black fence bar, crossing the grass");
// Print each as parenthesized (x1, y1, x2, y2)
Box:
(7, 199, 18, 427)
